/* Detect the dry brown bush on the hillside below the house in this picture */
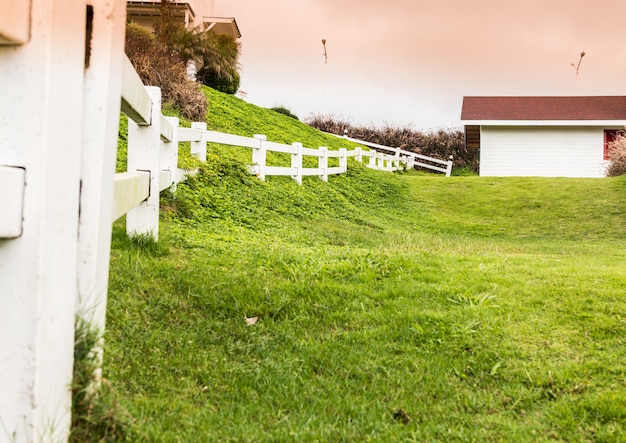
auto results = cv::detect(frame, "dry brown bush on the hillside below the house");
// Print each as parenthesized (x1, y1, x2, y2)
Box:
(126, 23, 208, 121)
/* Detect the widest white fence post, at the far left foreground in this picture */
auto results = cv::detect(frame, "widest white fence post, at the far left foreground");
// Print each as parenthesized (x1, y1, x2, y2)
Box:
(0, 0, 87, 443)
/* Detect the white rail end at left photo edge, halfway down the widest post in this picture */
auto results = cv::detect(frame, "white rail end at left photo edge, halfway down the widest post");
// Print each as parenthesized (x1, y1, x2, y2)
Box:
(0, 166, 26, 239)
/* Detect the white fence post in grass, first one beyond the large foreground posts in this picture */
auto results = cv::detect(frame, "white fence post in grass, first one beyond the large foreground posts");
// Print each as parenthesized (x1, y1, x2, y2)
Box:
(126, 86, 161, 240)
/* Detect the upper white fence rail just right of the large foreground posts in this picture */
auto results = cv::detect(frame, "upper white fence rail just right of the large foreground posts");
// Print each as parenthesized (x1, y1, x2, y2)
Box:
(121, 56, 152, 126)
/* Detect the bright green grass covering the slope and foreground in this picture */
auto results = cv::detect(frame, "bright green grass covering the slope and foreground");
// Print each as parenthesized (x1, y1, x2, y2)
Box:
(105, 87, 626, 441)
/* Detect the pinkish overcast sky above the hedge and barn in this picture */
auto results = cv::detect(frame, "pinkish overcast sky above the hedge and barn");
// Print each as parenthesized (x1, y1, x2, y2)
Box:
(215, 0, 626, 129)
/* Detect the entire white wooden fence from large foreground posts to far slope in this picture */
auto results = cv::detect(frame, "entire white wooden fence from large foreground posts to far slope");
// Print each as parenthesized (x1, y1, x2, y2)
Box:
(0, 0, 448, 443)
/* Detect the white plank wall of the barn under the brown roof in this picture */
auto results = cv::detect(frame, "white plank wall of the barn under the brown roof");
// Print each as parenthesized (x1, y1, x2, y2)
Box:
(480, 126, 623, 177)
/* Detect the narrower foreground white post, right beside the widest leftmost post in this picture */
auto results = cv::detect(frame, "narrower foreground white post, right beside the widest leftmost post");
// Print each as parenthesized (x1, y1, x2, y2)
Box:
(72, 0, 126, 386)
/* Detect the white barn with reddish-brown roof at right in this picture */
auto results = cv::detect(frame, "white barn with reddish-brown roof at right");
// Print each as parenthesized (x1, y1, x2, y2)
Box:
(461, 96, 626, 177)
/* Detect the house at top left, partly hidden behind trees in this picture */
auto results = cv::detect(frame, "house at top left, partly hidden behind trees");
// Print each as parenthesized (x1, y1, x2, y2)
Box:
(126, 0, 241, 39)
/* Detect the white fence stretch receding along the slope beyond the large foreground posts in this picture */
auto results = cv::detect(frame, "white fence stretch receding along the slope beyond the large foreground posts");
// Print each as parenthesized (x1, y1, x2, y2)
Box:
(112, 57, 415, 239)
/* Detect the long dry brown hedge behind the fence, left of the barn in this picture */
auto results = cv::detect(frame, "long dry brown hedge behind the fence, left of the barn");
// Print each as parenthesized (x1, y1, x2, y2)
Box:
(305, 115, 478, 171)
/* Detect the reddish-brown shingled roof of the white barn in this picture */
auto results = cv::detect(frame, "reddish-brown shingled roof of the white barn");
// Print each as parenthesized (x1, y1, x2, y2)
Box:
(461, 96, 626, 121)
